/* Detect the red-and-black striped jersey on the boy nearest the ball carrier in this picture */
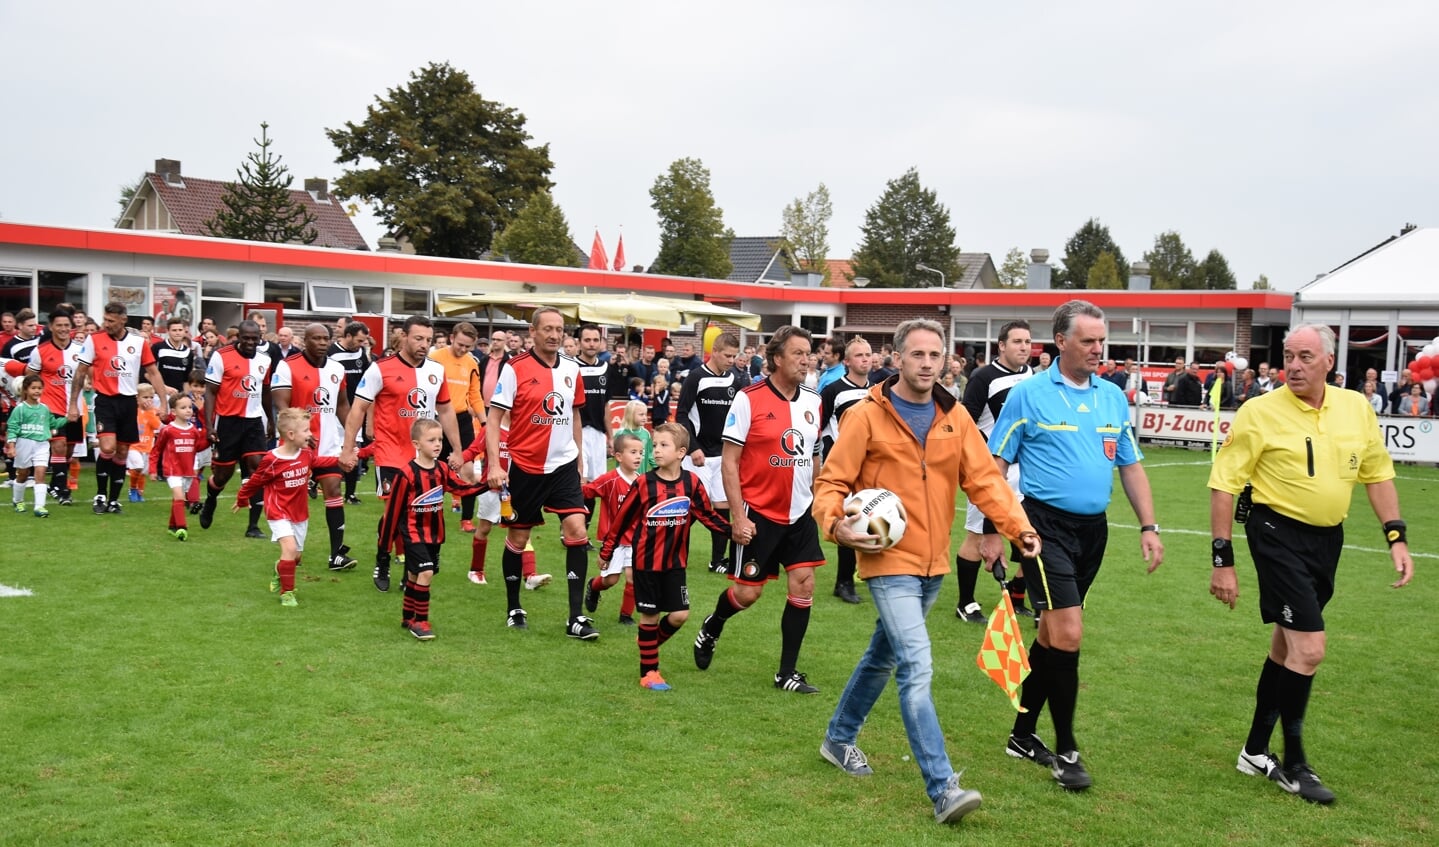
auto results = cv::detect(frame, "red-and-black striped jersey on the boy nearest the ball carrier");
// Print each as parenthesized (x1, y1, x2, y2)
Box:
(600, 470, 730, 571)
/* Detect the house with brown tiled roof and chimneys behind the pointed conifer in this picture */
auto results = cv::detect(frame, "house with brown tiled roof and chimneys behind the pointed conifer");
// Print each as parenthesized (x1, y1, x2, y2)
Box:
(115, 158, 370, 250)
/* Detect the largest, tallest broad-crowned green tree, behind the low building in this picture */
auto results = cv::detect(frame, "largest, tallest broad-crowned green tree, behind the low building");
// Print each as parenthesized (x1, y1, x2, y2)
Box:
(325, 62, 554, 259)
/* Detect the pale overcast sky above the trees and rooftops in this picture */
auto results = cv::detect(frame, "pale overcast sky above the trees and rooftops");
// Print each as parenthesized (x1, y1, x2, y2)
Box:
(0, 0, 1439, 289)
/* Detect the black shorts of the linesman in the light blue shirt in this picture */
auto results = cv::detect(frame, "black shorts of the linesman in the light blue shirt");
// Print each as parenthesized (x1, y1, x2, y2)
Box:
(1020, 498, 1109, 610)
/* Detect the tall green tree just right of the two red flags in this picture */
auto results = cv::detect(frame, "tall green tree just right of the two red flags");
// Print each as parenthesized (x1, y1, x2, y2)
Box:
(649, 158, 734, 279)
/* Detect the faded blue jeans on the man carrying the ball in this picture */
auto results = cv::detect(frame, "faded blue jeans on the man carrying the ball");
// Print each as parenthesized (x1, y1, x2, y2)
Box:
(826, 577, 954, 800)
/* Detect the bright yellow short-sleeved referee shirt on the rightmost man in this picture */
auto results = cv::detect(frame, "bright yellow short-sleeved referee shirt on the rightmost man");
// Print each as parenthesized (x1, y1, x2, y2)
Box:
(1209, 385, 1394, 526)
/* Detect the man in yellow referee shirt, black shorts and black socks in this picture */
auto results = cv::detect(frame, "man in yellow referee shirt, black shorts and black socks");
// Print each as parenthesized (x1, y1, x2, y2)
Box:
(1209, 324, 1415, 804)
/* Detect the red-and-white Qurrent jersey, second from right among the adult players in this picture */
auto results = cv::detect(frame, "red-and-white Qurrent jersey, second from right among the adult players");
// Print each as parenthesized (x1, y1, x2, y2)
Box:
(491, 351, 584, 473)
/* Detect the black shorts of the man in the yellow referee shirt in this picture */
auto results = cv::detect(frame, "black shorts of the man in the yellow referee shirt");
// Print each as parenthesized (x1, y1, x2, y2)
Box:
(1245, 503, 1344, 633)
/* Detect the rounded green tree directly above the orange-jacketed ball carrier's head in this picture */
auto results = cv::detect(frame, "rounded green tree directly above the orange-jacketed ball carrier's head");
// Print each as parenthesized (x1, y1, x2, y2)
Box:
(855, 168, 963, 288)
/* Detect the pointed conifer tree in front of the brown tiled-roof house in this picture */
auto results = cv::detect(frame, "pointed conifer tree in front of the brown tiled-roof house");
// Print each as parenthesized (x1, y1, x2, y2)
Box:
(204, 124, 319, 244)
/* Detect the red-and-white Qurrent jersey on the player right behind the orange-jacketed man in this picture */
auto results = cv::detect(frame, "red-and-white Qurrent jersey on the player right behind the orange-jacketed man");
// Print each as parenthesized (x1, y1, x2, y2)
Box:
(724, 380, 820, 523)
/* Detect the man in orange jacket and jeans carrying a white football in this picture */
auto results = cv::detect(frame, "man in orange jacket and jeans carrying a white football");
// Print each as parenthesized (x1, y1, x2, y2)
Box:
(813, 319, 1040, 823)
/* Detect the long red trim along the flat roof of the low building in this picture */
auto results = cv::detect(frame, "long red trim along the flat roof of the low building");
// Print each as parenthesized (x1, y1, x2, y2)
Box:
(0, 221, 1294, 311)
